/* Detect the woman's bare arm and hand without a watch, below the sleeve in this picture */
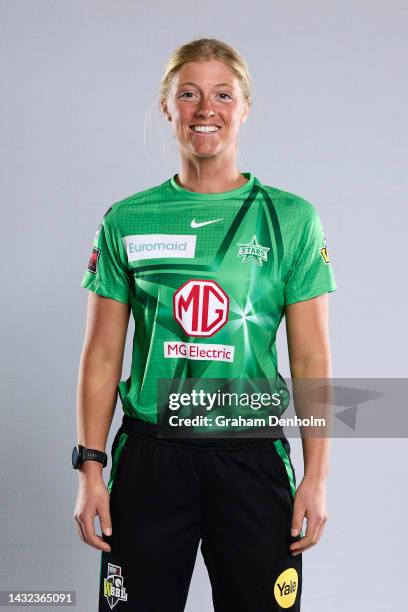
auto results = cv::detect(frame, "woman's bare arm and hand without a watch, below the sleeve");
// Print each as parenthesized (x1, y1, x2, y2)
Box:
(286, 293, 331, 554)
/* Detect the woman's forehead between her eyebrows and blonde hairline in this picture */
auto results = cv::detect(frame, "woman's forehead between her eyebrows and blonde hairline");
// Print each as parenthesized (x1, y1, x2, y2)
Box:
(173, 59, 239, 87)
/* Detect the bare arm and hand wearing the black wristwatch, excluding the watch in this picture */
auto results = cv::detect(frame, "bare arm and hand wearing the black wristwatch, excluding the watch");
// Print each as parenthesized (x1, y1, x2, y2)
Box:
(74, 291, 130, 551)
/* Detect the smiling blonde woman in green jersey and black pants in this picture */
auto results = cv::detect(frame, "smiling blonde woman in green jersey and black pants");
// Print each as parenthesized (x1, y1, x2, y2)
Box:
(73, 39, 336, 612)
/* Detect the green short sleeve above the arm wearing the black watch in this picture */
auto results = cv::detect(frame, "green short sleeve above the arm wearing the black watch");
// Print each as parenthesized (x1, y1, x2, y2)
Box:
(81, 207, 130, 304)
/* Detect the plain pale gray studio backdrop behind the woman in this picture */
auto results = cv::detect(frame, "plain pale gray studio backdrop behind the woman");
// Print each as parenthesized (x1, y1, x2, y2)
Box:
(0, 0, 408, 612)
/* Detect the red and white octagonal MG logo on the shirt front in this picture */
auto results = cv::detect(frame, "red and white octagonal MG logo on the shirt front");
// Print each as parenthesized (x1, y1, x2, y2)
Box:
(173, 279, 229, 336)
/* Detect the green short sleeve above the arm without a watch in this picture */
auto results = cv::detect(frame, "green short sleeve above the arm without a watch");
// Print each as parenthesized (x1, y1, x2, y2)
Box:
(284, 203, 337, 305)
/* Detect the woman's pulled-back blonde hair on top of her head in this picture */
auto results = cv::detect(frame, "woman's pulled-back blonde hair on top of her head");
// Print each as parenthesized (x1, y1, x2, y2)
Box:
(159, 38, 252, 106)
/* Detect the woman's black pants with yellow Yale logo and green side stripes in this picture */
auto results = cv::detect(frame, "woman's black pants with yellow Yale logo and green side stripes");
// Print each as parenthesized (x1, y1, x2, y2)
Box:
(98, 415, 302, 612)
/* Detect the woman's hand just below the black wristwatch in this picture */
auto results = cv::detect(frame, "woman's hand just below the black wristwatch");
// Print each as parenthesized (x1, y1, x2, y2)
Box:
(74, 475, 112, 552)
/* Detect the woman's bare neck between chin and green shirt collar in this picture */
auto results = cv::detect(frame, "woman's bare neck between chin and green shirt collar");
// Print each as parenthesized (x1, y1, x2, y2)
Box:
(176, 156, 247, 193)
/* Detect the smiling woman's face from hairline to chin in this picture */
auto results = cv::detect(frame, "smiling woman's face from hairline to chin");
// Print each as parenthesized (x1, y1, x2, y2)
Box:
(162, 59, 249, 157)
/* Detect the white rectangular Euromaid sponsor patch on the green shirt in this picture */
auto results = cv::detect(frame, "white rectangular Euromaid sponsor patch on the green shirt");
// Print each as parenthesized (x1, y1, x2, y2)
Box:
(123, 234, 197, 261)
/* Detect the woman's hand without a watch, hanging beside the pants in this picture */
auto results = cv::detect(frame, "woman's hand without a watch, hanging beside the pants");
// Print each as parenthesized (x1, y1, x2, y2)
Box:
(289, 477, 327, 556)
